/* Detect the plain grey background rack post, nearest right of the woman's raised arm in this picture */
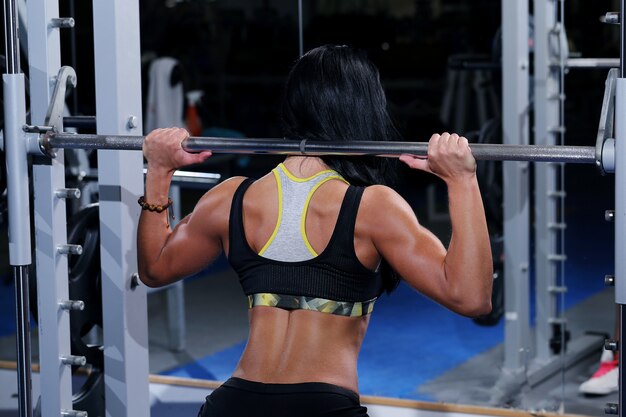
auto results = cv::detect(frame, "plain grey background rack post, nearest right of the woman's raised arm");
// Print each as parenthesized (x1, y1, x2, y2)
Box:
(502, 0, 531, 373)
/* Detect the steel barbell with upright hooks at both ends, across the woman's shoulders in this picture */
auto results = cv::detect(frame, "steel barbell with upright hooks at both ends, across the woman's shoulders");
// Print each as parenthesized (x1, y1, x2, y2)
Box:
(23, 63, 615, 167)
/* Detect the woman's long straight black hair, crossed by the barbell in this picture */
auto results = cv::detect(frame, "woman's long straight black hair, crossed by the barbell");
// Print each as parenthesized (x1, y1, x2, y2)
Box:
(281, 45, 400, 292)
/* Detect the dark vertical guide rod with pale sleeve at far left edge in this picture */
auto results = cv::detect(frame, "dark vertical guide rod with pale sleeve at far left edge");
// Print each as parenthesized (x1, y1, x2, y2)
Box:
(2, 0, 33, 417)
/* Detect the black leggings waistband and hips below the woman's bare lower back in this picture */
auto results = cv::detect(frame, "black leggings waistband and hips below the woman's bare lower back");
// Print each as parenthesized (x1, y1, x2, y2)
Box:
(198, 378, 368, 417)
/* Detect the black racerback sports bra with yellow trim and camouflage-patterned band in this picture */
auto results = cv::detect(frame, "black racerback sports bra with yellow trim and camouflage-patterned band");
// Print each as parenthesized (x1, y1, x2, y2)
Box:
(228, 164, 383, 317)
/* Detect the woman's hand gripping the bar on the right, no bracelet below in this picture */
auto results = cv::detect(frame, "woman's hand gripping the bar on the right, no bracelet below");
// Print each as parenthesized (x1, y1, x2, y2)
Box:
(400, 133, 476, 182)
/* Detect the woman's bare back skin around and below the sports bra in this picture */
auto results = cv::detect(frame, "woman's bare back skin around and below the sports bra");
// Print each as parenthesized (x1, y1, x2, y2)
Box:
(227, 160, 379, 391)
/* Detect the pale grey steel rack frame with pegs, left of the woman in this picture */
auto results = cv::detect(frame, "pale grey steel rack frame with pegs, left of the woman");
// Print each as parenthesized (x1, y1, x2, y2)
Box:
(3, 0, 149, 417)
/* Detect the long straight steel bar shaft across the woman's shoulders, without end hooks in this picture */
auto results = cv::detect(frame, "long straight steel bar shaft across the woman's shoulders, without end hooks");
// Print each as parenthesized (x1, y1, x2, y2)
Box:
(41, 132, 596, 164)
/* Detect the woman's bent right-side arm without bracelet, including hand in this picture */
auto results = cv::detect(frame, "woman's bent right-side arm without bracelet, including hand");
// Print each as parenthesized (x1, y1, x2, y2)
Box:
(369, 134, 493, 316)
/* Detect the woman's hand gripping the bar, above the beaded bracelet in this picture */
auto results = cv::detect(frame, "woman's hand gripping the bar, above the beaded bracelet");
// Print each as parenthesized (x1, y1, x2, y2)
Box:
(143, 127, 211, 172)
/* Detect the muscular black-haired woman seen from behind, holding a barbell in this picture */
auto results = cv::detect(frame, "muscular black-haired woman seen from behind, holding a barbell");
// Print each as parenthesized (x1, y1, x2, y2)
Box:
(138, 46, 492, 417)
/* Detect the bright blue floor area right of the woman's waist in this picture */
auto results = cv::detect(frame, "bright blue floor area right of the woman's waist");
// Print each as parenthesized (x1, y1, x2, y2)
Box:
(358, 284, 504, 400)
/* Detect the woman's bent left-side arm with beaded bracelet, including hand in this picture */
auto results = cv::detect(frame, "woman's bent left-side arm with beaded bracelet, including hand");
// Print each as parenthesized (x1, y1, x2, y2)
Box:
(137, 128, 219, 287)
